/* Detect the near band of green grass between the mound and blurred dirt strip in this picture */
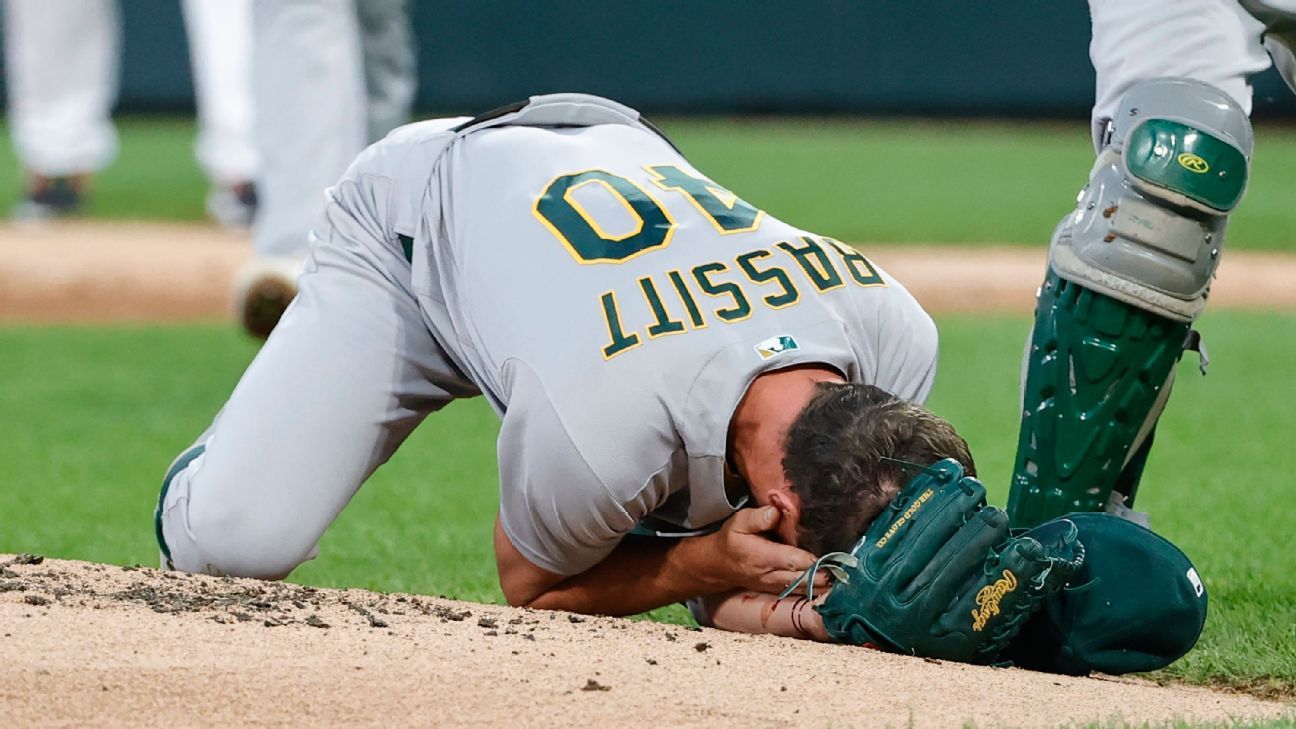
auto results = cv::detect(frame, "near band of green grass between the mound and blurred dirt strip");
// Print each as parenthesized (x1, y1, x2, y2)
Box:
(0, 313, 1296, 697)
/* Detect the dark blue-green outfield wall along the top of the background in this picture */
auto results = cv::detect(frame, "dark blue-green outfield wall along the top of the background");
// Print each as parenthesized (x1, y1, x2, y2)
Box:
(7, 0, 1296, 118)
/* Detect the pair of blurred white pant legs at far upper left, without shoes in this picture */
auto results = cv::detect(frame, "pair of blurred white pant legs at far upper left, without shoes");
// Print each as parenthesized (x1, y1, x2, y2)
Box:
(4, 0, 257, 184)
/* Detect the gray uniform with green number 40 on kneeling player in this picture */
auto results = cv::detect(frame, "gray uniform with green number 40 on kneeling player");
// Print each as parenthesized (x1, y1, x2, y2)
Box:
(159, 95, 937, 576)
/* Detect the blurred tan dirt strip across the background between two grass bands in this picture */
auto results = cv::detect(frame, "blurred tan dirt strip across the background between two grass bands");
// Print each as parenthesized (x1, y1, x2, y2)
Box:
(0, 222, 1296, 323)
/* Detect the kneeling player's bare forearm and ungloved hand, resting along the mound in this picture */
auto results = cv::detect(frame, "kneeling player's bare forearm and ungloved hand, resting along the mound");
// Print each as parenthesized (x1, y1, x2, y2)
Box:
(495, 508, 814, 615)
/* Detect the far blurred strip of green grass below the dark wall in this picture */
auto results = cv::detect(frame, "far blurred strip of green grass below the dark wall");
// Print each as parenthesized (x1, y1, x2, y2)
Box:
(0, 117, 1296, 250)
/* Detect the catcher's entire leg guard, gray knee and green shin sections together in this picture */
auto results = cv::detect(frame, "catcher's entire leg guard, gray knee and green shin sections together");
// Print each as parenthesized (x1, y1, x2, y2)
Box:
(1008, 78, 1253, 527)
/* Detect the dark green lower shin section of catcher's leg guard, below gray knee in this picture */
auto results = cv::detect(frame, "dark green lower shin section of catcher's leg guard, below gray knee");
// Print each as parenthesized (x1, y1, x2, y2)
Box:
(1008, 269, 1190, 527)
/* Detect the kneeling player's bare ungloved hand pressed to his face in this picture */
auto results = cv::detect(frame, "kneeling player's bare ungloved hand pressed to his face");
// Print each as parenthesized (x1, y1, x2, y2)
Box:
(701, 506, 828, 593)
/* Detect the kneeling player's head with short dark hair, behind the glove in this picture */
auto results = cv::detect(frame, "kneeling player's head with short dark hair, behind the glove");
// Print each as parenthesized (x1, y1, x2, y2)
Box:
(783, 383, 976, 554)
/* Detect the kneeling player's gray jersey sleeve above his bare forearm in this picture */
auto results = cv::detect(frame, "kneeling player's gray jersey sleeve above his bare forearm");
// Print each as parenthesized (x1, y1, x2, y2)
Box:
(498, 366, 642, 575)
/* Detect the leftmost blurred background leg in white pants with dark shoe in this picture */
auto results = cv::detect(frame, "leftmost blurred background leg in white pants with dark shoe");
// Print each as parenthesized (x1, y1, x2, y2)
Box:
(4, 0, 121, 218)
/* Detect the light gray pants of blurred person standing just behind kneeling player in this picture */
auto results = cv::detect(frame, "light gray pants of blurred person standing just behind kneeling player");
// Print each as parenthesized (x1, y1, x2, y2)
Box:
(253, 0, 415, 256)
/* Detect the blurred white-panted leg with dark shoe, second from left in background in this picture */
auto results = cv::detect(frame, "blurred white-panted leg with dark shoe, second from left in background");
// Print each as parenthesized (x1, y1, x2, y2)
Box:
(181, 0, 258, 227)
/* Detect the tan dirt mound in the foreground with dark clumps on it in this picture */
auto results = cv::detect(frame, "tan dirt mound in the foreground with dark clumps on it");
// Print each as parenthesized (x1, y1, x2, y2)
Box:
(0, 555, 1291, 729)
